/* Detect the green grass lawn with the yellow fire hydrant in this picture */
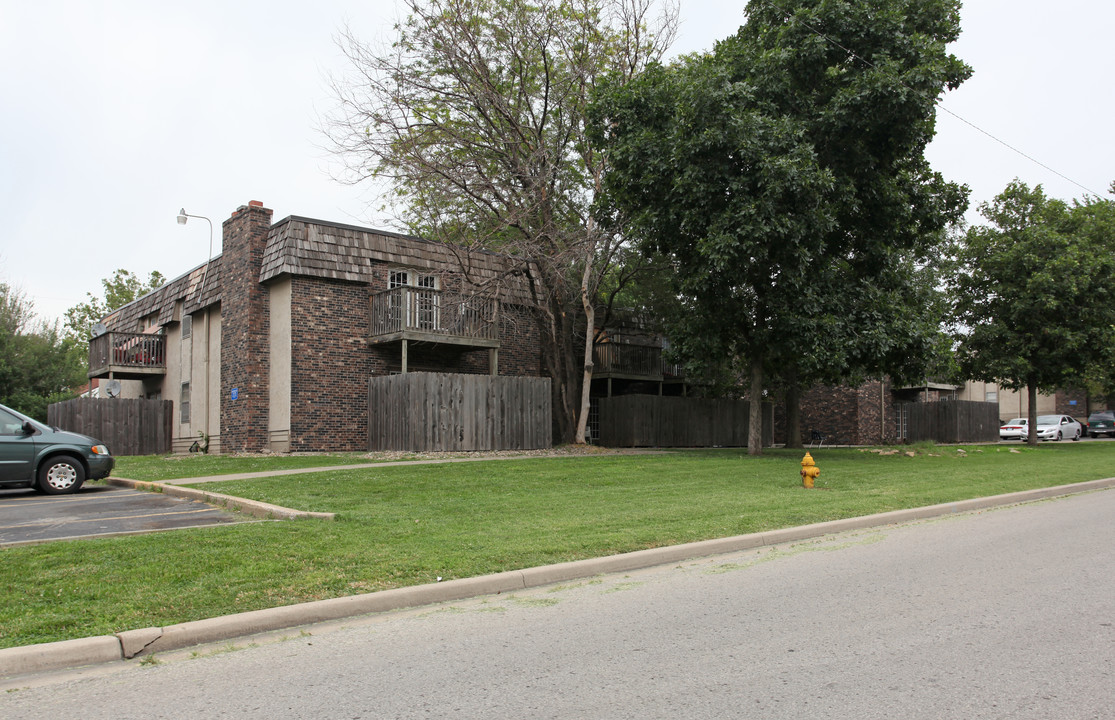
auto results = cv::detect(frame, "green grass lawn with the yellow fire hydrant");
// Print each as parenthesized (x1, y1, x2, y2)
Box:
(0, 442, 1115, 646)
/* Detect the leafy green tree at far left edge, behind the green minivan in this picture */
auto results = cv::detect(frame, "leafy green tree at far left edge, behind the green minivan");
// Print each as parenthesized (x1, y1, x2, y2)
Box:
(0, 283, 85, 421)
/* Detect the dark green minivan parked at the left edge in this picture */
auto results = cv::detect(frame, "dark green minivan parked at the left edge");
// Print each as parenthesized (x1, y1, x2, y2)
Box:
(0, 405, 115, 495)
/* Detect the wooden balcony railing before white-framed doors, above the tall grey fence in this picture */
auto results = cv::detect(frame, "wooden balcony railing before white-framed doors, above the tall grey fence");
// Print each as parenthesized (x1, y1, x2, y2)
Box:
(370, 286, 500, 348)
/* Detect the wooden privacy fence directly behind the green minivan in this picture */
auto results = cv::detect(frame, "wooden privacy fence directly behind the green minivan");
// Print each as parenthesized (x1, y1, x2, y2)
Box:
(47, 398, 174, 455)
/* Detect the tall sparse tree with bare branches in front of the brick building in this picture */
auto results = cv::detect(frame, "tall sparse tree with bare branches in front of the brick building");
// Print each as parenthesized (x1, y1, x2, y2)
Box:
(327, 0, 677, 441)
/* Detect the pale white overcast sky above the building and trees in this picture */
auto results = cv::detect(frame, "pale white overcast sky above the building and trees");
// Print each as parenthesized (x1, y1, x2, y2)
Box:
(0, 0, 1115, 319)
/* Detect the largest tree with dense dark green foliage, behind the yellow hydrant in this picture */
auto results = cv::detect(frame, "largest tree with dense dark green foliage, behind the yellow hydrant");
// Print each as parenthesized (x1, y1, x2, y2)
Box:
(593, 0, 970, 454)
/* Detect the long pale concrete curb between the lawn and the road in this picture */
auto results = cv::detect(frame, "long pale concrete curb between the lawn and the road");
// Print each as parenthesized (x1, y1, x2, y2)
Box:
(0, 478, 1115, 678)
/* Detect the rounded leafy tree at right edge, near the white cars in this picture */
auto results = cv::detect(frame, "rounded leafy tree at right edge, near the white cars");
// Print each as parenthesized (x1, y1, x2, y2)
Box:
(953, 179, 1115, 445)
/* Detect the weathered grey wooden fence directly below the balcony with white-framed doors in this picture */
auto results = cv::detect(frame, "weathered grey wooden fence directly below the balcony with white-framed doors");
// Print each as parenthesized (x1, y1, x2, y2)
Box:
(368, 372, 552, 451)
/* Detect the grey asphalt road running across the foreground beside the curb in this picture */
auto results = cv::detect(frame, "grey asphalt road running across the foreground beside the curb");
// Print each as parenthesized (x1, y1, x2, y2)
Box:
(0, 490, 1115, 720)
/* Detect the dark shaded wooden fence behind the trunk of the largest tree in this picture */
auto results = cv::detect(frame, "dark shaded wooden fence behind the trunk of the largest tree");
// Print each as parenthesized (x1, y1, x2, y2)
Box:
(598, 395, 774, 447)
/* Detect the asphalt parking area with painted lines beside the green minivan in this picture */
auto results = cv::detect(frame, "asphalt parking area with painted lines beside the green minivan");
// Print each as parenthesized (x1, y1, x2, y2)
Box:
(0, 483, 251, 546)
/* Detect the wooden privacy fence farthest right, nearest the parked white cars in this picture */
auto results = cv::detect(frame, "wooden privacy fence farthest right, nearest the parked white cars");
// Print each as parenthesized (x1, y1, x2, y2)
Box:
(895, 400, 999, 442)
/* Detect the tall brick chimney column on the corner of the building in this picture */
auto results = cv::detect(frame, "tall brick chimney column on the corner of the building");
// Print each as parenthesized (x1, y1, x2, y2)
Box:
(221, 201, 272, 453)
